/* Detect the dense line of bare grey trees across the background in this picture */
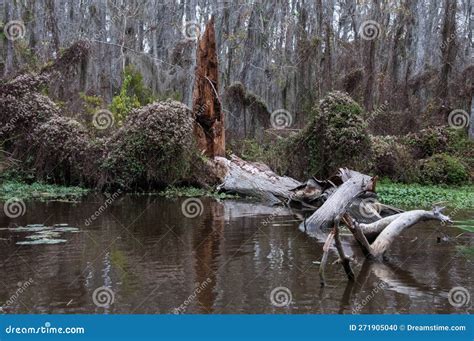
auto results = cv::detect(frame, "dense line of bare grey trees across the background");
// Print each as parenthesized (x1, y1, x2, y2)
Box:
(0, 0, 474, 133)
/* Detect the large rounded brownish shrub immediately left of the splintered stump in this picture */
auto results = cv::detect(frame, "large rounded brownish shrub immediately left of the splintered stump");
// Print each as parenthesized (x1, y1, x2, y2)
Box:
(102, 100, 195, 188)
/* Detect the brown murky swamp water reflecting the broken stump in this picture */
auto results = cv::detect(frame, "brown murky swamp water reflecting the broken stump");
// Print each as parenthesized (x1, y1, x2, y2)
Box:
(0, 195, 474, 314)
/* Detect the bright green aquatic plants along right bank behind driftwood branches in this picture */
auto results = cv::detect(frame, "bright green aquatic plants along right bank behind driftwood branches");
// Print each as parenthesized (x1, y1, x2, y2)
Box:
(377, 181, 474, 209)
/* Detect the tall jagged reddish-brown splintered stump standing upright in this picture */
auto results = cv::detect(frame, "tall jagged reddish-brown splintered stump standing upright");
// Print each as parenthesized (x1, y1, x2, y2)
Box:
(193, 18, 225, 157)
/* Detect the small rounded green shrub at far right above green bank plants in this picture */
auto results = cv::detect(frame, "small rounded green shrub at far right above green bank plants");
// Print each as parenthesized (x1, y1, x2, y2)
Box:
(420, 154, 469, 185)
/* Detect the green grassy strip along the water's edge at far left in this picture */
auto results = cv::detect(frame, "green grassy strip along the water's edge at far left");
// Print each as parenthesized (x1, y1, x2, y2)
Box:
(0, 181, 88, 200)
